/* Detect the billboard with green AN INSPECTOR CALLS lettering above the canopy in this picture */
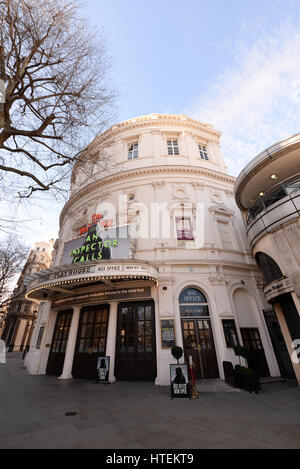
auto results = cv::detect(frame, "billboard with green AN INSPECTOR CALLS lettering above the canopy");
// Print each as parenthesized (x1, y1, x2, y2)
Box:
(60, 225, 130, 265)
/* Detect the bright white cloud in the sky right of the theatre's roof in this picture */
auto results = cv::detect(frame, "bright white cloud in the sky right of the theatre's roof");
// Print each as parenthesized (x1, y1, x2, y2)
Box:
(189, 23, 300, 176)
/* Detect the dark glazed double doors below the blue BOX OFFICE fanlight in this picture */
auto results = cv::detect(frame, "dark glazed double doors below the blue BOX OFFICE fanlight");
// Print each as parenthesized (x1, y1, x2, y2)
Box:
(181, 318, 219, 379)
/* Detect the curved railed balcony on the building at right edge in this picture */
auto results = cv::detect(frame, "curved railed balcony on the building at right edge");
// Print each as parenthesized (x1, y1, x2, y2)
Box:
(246, 174, 300, 247)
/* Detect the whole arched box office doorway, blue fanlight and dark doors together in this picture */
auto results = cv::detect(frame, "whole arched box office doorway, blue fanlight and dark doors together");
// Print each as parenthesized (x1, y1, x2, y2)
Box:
(179, 287, 219, 379)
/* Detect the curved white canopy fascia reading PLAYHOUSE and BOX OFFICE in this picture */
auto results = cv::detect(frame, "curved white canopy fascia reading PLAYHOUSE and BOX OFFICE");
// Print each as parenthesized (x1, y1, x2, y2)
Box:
(30, 262, 157, 289)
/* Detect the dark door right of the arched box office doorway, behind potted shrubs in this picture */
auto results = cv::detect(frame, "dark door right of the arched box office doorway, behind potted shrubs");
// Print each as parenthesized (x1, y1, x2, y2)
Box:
(241, 327, 270, 377)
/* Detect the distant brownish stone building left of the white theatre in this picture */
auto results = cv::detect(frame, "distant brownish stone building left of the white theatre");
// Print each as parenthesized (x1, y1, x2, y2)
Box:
(2, 240, 54, 352)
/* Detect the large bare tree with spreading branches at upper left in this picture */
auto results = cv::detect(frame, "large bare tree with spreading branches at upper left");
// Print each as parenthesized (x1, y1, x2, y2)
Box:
(0, 0, 114, 198)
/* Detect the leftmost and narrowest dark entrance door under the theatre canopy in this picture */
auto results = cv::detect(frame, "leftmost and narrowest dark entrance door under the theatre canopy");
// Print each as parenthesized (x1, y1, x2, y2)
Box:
(46, 309, 73, 376)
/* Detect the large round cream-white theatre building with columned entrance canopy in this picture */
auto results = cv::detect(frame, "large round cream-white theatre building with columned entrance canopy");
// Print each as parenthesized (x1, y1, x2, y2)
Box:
(26, 114, 281, 385)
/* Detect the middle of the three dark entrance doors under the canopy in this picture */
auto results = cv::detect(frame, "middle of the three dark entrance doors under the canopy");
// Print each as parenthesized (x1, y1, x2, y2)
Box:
(72, 305, 109, 379)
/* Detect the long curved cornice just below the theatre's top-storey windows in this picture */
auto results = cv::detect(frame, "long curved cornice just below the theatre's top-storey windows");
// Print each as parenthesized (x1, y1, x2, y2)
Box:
(59, 165, 235, 225)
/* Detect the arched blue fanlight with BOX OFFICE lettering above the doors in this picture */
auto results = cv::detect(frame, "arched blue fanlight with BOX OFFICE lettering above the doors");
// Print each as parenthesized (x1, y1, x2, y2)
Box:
(179, 287, 209, 317)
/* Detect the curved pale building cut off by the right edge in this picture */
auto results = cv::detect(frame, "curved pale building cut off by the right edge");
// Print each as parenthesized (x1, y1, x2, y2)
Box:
(234, 134, 300, 383)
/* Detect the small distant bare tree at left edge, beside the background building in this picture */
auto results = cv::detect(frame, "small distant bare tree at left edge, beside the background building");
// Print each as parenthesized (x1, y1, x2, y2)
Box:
(0, 235, 29, 308)
